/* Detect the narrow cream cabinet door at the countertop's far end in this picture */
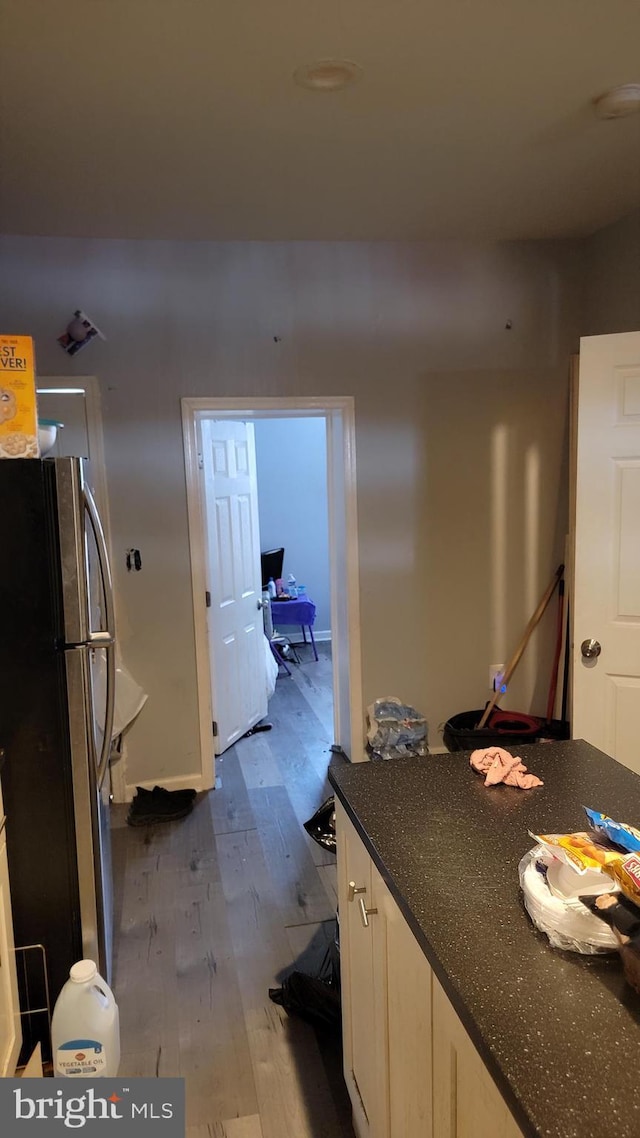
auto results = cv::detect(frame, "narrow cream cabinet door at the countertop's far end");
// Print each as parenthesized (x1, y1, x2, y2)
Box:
(336, 802, 387, 1138)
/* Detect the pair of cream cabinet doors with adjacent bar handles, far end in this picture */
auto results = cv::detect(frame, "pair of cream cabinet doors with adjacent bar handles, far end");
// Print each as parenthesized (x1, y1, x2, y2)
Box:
(336, 802, 432, 1138)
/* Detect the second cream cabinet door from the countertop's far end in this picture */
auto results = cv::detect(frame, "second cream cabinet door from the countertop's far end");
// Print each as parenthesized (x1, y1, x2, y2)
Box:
(372, 868, 433, 1138)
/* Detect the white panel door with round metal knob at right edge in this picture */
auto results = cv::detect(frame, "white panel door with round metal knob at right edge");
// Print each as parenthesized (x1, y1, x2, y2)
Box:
(572, 332, 640, 773)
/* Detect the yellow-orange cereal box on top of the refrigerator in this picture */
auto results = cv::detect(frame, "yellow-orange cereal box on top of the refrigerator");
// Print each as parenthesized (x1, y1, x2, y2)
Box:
(0, 336, 40, 459)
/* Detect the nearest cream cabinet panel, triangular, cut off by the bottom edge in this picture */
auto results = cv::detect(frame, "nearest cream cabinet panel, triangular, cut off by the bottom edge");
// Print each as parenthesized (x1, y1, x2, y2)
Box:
(433, 976, 523, 1138)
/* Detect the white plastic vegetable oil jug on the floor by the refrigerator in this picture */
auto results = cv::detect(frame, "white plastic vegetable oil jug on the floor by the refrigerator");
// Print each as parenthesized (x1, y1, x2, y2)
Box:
(51, 960, 120, 1079)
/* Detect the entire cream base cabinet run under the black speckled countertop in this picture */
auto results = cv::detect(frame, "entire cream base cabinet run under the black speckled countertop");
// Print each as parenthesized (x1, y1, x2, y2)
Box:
(336, 801, 522, 1138)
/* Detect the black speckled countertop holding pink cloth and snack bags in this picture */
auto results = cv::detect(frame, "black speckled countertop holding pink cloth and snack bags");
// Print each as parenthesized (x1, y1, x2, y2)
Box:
(329, 741, 640, 1138)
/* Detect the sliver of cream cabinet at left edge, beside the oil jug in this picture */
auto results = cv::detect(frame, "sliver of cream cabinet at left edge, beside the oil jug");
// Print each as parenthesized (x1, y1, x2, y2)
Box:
(0, 790, 22, 1079)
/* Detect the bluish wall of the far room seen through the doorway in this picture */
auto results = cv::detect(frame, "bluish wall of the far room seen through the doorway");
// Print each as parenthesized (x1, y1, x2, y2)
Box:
(255, 419, 331, 640)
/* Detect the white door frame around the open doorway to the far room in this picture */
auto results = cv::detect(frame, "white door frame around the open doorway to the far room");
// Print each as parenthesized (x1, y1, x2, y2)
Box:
(181, 396, 366, 789)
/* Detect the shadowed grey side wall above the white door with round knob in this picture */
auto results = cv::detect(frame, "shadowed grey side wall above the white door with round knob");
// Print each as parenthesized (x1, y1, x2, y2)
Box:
(582, 209, 640, 336)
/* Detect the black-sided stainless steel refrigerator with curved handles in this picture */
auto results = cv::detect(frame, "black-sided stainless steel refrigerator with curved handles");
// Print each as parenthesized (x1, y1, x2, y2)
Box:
(0, 459, 115, 1050)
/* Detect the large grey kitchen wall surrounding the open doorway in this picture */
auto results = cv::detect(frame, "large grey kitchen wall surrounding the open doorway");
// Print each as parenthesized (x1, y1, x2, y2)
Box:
(0, 238, 582, 783)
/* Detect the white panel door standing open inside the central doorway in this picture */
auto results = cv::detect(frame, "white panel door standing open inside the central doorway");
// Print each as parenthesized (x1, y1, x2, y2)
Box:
(202, 419, 266, 754)
